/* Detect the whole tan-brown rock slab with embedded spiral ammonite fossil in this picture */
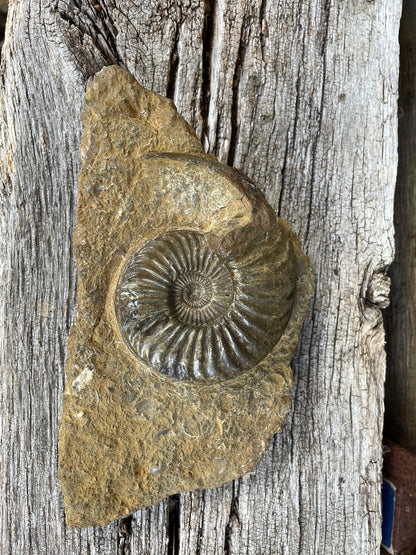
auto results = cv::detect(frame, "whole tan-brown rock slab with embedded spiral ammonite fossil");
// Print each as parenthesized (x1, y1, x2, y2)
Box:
(59, 66, 313, 527)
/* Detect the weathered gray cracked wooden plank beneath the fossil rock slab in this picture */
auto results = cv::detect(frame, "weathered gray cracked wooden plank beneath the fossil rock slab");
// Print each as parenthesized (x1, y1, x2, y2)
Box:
(0, 0, 401, 555)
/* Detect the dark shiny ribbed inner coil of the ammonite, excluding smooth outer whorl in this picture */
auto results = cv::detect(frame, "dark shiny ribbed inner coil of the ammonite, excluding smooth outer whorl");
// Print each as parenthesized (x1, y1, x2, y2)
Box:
(115, 230, 293, 381)
